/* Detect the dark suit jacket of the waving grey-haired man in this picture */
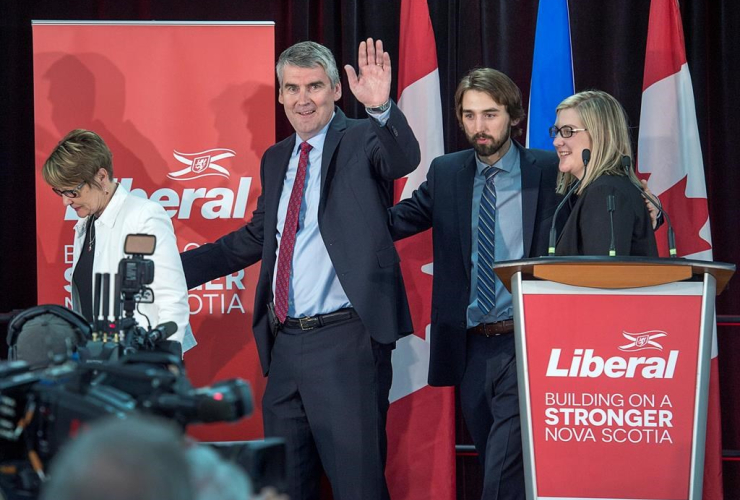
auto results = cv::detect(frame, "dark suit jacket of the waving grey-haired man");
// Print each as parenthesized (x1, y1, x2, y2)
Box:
(182, 104, 421, 375)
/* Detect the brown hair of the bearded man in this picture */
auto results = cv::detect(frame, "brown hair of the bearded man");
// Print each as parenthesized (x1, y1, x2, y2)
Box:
(455, 68, 526, 137)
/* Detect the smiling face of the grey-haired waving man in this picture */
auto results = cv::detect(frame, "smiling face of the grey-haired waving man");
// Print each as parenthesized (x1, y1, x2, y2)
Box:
(278, 64, 342, 141)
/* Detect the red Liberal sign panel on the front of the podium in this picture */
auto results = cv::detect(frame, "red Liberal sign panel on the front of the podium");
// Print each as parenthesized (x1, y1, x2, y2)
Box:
(523, 282, 702, 499)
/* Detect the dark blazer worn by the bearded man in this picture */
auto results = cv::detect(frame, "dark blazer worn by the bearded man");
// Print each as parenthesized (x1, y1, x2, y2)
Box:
(389, 141, 567, 386)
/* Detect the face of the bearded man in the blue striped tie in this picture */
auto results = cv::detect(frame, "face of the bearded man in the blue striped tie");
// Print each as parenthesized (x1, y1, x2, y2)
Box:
(460, 90, 516, 165)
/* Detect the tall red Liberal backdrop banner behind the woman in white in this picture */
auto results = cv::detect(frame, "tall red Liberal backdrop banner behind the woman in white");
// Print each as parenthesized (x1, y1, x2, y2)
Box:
(33, 22, 275, 440)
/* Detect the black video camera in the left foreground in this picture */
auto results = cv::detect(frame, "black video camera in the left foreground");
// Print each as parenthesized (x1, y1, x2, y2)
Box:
(0, 235, 253, 499)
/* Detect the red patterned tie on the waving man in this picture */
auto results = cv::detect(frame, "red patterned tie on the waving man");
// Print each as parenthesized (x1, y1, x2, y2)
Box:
(275, 142, 311, 323)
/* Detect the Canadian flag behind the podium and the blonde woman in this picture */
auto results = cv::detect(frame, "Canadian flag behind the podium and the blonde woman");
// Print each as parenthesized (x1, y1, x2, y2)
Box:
(638, 0, 723, 500)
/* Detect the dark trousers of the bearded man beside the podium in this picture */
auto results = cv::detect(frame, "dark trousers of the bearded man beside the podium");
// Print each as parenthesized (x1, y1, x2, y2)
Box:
(460, 333, 525, 500)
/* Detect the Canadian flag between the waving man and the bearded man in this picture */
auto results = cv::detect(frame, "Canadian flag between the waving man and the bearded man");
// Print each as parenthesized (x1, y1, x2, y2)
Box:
(386, 0, 455, 500)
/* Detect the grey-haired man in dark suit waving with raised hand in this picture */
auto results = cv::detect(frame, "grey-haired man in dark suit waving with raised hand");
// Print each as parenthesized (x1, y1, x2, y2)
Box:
(182, 39, 420, 500)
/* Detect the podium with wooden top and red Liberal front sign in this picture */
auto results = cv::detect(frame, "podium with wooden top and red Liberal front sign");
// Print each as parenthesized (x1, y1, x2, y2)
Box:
(495, 257, 735, 500)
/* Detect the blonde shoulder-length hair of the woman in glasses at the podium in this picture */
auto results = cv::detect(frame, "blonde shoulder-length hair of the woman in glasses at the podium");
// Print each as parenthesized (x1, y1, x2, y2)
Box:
(557, 90, 637, 194)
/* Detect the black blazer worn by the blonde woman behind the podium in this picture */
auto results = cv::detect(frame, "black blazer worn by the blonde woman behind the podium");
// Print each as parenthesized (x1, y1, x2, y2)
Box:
(555, 175, 658, 257)
